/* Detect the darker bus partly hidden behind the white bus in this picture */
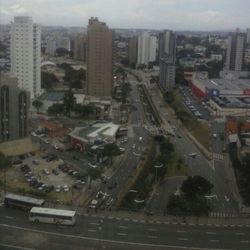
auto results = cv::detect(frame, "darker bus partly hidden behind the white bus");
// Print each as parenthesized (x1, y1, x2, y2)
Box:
(4, 193, 45, 211)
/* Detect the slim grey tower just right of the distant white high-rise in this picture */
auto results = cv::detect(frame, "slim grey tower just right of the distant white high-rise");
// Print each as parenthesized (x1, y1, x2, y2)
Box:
(158, 30, 176, 90)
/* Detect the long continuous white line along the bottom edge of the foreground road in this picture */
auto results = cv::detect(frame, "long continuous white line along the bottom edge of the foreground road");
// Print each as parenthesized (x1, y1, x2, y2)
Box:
(0, 223, 231, 250)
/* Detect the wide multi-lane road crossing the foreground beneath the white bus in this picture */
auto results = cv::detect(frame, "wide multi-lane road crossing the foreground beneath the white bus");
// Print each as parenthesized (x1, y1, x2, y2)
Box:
(0, 208, 250, 250)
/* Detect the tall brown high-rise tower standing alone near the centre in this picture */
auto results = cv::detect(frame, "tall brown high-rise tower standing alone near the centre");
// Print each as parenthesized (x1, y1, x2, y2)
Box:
(87, 17, 113, 97)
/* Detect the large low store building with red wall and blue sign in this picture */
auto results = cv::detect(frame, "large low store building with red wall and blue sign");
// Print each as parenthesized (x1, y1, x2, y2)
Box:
(191, 71, 250, 116)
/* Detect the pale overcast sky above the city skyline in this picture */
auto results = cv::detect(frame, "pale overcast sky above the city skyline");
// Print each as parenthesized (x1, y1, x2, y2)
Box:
(0, 0, 250, 30)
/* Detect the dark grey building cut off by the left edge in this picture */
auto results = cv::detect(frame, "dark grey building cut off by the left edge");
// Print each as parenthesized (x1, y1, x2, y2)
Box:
(0, 74, 30, 142)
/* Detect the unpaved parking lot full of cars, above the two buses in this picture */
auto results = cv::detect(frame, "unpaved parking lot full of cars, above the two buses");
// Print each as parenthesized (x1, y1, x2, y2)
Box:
(9, 152, 87, 197)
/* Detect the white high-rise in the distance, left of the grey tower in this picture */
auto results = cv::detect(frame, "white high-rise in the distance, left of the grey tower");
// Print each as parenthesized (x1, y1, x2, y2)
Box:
(137, 31, 157, 65)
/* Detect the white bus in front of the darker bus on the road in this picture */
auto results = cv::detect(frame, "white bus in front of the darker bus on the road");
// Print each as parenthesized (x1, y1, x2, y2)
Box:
(29, 207, 76, 225)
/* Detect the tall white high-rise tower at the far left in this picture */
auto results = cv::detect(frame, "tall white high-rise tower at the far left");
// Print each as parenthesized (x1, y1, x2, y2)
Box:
(10, 16, 41, 99)
